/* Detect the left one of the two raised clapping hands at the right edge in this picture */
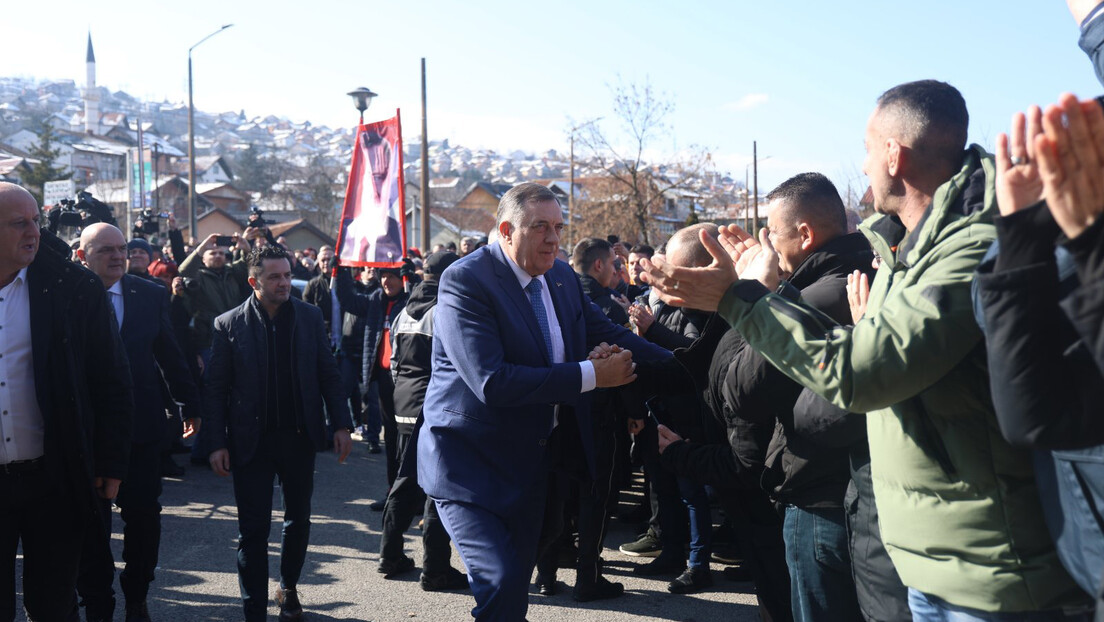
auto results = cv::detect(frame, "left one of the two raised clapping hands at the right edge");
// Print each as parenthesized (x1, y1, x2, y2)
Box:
(996, 106, 1043, 215)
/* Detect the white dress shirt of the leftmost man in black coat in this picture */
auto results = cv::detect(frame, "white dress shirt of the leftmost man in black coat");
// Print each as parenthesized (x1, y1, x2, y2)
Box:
(0, 267, 45, 463)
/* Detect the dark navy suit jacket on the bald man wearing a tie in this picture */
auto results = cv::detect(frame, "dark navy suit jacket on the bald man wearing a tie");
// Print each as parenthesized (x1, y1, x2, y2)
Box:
(119, 274, 200, 443)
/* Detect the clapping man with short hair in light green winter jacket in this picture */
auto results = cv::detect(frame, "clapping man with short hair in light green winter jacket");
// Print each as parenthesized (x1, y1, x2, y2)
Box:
(646, 81, 1087, 621)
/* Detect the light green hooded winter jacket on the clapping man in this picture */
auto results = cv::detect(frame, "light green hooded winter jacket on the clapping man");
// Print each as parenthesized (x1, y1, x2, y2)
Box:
(719, 146, 1085, 612)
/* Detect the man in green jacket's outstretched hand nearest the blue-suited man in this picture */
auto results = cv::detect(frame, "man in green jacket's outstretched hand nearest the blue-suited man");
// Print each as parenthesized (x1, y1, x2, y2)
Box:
(640, 230, 736, 312)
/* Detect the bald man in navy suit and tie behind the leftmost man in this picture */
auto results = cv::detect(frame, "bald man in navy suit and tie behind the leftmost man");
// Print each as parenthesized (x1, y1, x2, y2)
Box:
(76, 223, 199, 622)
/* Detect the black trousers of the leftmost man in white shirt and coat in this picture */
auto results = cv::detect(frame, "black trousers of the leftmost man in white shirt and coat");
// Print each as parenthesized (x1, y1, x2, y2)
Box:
(0, 464, 83, 622)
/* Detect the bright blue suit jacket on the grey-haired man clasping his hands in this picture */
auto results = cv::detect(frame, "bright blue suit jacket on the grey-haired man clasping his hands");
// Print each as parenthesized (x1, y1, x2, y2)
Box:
(417, 243, 670, 516)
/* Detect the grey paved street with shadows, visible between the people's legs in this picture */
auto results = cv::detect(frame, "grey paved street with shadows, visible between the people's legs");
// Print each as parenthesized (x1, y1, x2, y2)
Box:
(20, 443, 758, 622)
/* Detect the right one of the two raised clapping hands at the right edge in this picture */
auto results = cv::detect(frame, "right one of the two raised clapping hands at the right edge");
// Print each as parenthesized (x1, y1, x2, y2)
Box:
(1034, 93, 1104, 240)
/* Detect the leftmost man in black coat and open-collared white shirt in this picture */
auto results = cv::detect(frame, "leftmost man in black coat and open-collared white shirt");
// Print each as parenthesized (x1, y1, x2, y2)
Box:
(0, 182, 134, 621)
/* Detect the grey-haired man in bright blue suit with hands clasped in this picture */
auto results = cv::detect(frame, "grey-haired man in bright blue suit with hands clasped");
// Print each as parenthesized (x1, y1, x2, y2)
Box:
(417, 183, 670, 622)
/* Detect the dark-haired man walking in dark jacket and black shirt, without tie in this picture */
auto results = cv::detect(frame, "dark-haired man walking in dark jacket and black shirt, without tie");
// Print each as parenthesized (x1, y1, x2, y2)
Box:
(203, 246, 352, 622)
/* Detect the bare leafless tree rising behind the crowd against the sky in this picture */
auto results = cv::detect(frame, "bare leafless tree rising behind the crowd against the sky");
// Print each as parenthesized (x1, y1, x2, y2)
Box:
(576, 76, 712, 243)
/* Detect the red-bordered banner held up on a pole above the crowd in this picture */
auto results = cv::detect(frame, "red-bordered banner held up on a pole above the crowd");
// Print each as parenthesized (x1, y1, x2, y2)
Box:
(337, 109, 406, 267)
